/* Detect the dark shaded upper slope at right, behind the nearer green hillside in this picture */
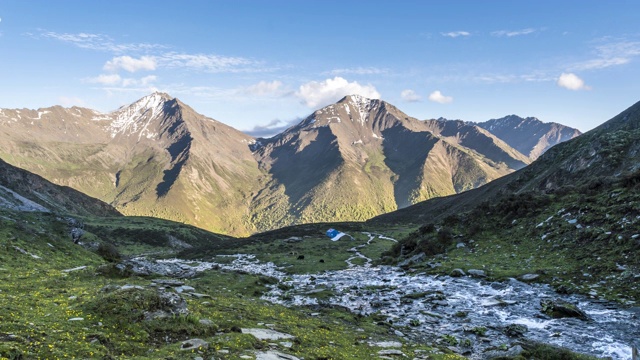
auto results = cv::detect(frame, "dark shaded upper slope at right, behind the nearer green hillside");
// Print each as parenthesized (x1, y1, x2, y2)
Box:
(372, 103, 640, 223)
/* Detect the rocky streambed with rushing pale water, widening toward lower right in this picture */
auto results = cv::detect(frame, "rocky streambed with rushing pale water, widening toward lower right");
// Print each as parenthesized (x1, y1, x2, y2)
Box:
(138, 235, 640, 359)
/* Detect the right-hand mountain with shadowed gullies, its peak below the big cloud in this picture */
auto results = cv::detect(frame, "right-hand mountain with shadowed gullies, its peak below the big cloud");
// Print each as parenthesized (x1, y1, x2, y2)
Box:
(252, 95, 528, 231)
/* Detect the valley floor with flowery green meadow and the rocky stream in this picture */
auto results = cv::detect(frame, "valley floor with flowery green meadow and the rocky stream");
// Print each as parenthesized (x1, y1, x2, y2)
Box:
(0, 214, 640, 360)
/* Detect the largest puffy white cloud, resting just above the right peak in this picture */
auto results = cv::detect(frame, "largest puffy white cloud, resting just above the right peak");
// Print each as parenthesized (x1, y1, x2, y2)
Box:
(296, 76, 380, 108)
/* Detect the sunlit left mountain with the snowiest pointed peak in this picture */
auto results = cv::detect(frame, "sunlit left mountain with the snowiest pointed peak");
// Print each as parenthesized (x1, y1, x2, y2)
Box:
(0, 93, 259, 233)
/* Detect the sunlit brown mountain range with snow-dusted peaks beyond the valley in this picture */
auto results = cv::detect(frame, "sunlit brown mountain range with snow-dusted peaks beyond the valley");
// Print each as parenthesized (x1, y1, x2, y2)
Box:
(0, 93, 580, 235)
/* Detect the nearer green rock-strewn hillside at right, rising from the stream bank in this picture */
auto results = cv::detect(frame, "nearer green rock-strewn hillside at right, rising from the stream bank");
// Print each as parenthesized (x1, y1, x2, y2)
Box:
(385, 176, 640, 305)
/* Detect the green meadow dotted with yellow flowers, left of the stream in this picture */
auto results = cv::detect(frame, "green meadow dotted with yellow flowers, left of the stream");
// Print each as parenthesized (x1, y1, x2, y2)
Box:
(0, 212, 459, 359)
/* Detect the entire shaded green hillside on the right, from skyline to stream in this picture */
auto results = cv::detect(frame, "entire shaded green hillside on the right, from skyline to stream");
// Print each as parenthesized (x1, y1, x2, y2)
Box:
(378, 100, 640, 304)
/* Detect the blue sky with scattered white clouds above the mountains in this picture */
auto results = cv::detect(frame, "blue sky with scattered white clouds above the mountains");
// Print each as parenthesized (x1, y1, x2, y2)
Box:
(0, 0, 640, 135)
